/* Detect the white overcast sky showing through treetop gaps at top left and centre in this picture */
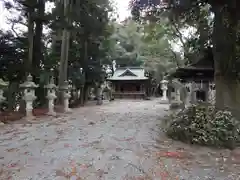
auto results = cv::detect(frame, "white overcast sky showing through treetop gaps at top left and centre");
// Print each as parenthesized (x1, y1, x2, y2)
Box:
(0, 0, 130, 30)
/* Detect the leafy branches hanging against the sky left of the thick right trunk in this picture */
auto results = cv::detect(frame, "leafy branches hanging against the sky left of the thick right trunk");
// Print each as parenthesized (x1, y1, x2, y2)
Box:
(130, 0, 213, 63)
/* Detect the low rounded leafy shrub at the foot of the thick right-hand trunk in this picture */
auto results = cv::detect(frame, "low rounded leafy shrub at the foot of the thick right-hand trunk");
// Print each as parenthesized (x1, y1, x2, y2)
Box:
(167, 104, 240, 149)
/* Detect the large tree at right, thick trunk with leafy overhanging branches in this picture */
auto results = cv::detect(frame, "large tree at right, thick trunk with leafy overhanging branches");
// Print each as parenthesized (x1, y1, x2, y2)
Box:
(130, 0, 240, 115)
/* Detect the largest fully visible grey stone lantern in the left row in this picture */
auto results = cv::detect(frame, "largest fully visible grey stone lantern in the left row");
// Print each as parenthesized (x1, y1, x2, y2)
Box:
(20, 74, 39, 120)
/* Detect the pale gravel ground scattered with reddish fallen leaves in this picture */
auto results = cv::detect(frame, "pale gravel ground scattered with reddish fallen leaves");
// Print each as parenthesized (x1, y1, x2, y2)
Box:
(0, 99, 240, 180)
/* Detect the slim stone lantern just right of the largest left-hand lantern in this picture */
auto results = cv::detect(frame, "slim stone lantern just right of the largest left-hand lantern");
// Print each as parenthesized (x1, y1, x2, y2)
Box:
(44, 77, 57, 116)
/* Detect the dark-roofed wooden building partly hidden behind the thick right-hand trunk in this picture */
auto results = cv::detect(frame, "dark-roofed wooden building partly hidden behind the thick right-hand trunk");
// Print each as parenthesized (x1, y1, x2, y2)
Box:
(170, 48, 214, 103)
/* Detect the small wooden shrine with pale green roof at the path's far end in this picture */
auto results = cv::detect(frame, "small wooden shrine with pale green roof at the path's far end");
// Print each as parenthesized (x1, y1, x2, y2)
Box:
(108, 67, 148, 98)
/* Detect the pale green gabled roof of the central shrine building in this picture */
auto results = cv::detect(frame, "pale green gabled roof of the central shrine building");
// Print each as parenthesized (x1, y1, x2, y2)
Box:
(108, 67, 148, 80)
